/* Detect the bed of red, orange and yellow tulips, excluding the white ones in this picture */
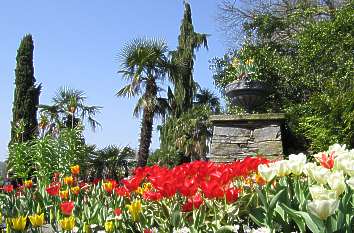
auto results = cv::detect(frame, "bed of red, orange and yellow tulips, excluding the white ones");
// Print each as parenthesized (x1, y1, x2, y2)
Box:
(1, 157, 269, 232)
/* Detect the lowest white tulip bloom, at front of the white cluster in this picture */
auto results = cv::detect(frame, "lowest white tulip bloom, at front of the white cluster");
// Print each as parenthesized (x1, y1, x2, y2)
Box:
(307, 199, 339, 220)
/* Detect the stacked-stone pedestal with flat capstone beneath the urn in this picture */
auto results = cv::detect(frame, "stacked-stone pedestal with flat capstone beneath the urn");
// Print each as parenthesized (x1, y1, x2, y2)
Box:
(208, 113, 285, 162)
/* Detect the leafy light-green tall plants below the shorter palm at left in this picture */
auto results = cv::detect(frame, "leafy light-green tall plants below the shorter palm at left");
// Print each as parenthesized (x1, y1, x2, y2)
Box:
(8, 127, 88, 182)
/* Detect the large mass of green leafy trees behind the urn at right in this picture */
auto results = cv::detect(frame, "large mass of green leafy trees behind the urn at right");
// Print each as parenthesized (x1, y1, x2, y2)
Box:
(212, 1, 354, 151)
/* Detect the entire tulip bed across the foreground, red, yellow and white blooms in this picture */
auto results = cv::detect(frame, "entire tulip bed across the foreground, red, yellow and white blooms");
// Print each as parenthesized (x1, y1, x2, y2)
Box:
(0, 145, 354, 233)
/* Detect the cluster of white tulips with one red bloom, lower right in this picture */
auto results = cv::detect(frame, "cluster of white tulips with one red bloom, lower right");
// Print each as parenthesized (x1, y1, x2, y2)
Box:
(254, 144, 354, 233)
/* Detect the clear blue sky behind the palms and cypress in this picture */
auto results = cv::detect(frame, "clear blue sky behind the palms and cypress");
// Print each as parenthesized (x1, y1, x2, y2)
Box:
(0, 0, 225, 160)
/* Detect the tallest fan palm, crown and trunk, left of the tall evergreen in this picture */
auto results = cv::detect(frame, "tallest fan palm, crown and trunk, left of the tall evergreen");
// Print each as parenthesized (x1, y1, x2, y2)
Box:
(117, 39, 171, 167)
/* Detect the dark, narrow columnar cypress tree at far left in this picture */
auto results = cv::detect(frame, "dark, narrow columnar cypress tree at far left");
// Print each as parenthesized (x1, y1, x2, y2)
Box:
(10, 34, 41, 144)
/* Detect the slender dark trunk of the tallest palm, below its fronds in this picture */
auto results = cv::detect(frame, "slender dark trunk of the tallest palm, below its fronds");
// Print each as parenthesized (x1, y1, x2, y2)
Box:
(137, 108, 154, 167)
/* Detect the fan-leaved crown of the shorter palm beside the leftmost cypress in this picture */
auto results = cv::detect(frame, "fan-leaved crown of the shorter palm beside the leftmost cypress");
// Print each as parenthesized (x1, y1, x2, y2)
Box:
(39, 87, 102, 134)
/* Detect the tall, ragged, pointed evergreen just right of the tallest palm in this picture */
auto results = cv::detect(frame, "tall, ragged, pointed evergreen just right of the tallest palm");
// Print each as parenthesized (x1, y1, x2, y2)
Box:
(172, 2, 208, 116)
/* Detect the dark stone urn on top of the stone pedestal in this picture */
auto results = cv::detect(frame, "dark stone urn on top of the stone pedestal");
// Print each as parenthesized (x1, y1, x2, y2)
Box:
(225, 75, 267, 113)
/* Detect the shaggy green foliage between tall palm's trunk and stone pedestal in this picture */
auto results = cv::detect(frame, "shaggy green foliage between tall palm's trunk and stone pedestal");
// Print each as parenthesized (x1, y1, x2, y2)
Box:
(150, 105, 212, 166)
